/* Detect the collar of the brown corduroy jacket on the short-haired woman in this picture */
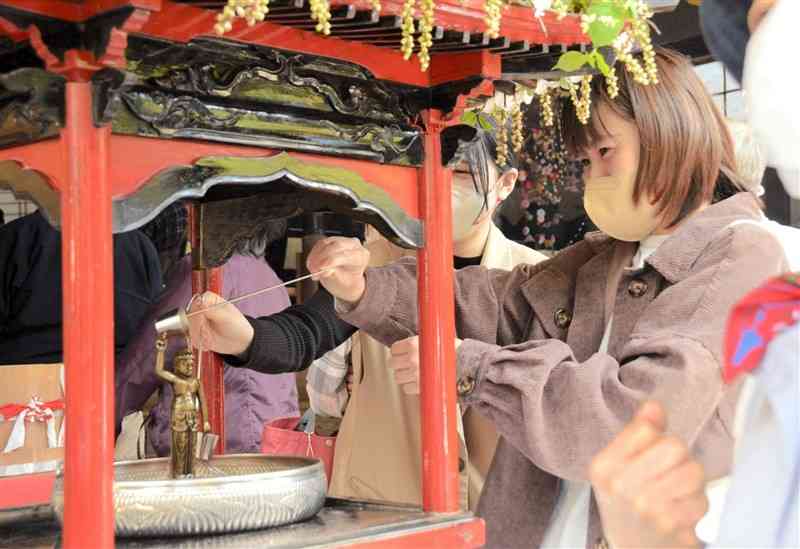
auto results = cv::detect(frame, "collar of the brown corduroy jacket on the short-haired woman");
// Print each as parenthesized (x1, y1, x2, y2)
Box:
(584, 192, 764, 284)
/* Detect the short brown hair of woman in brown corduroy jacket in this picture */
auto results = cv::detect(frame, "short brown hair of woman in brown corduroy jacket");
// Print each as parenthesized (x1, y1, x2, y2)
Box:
(561, 48, 744, 226)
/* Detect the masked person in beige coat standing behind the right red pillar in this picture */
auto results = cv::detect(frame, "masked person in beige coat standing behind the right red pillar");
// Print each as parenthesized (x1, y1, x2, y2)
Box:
(307, 120, 546, 509)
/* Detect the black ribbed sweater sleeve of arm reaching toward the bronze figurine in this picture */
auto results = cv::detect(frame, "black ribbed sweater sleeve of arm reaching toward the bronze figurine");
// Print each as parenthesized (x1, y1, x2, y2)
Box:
(222, 288, 356, 374)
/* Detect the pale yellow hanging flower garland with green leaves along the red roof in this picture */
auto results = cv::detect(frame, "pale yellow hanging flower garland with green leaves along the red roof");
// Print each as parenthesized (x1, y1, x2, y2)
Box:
(214, 0, 658, 164)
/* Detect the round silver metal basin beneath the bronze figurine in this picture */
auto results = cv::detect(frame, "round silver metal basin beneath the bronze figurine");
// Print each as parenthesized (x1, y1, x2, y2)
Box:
(53, 454, 327, 536)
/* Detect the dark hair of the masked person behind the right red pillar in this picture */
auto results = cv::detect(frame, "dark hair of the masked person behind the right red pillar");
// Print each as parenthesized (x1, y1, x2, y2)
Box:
(441, 114, 519, 214)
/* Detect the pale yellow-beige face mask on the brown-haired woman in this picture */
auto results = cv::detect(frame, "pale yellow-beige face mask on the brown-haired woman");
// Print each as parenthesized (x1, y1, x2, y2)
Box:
(583, 172, 661, 242)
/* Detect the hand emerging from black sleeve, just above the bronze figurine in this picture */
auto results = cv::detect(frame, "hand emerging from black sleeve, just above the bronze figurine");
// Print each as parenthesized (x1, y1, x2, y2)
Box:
(188, 292, 253, 356)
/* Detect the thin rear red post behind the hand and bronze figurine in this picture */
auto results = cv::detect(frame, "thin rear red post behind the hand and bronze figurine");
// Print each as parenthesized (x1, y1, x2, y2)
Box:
(189, 204, 230, 454)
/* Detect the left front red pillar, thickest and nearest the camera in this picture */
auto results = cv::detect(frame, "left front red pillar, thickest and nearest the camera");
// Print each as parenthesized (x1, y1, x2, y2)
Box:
(61, 82, 114, 549)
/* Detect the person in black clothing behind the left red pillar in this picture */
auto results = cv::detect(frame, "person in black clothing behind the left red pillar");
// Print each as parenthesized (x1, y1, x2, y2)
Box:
(0, 211, 162, 364)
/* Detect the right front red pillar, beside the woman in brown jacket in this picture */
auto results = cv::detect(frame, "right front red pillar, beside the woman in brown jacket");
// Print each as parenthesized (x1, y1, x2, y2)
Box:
(418, 111, 459, 512)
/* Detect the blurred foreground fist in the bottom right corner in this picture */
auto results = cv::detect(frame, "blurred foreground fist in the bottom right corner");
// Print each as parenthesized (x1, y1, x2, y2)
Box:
(590, 402, 708, 549)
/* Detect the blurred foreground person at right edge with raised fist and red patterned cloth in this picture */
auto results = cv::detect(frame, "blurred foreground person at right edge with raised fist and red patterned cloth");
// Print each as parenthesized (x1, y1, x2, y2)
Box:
(591, 0, 800, 549)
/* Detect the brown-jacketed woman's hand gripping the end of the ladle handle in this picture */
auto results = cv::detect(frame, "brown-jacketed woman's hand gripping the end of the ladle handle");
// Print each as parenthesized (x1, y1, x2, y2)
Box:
(306, 236, 369, 304)
